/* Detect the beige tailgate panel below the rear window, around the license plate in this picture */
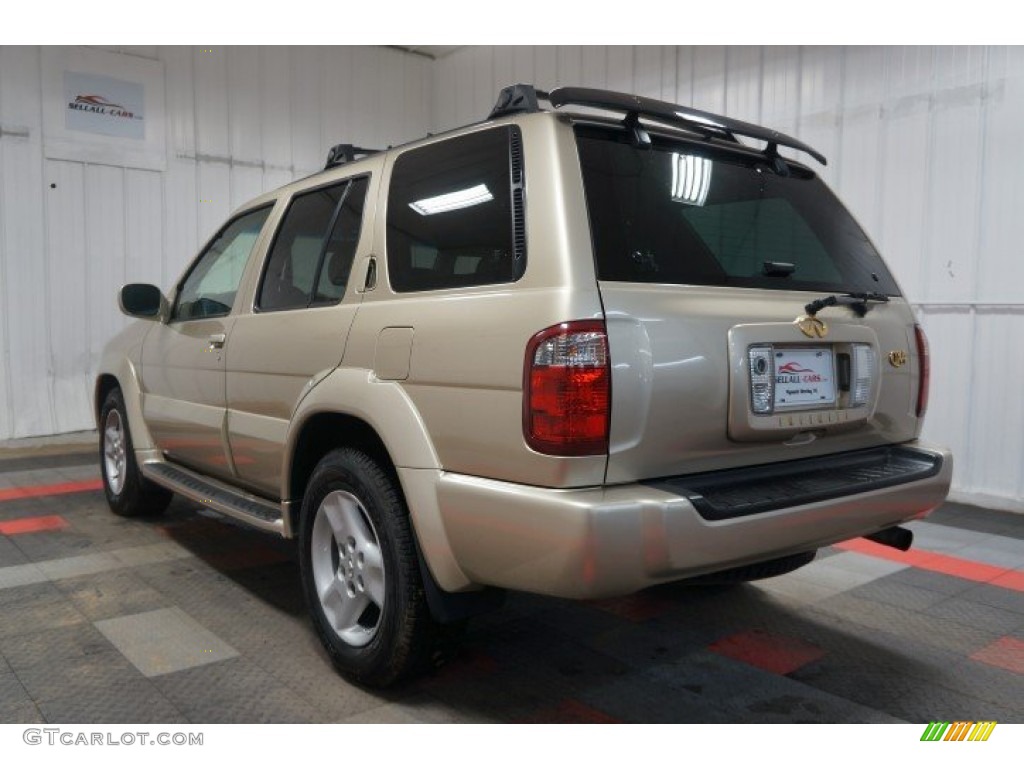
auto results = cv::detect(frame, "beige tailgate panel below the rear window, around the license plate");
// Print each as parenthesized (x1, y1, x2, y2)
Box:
(601, 283, 918, 482)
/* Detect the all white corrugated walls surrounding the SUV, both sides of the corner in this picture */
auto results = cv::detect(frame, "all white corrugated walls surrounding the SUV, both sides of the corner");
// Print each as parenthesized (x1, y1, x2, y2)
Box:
(0, 46, 1024, 518)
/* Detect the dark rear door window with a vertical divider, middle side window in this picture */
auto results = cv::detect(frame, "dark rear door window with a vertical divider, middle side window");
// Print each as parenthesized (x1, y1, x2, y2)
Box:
(256, 177, 369, 311)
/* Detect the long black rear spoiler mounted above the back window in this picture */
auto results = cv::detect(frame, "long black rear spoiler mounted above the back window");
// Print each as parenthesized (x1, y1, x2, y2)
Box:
(548, 86, 828, 165)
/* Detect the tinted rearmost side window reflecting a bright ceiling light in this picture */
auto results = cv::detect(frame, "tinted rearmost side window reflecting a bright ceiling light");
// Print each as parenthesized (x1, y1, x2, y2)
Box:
(387, 127, 526, 293)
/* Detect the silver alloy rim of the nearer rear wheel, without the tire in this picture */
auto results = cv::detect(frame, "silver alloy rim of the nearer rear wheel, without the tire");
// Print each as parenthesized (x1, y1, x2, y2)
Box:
(309, 490, 384, 647)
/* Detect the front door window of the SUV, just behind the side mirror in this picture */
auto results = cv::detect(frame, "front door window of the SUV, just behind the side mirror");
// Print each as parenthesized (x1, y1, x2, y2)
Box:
(171, 206, 272, 322)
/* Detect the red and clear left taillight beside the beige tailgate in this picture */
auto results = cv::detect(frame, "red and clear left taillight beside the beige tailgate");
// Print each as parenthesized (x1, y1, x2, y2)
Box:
(522, 321, 611, 456)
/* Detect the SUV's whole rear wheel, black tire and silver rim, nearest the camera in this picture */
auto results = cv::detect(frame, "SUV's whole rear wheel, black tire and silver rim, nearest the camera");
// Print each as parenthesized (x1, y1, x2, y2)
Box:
(299, 449, 439, 687)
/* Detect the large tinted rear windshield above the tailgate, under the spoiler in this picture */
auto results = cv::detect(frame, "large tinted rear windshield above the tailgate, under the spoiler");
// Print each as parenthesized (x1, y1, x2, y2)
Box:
(577, 126, 899, 296)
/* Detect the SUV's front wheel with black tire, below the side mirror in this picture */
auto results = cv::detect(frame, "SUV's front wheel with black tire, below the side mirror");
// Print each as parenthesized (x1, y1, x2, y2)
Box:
(99, 389, 174, 517)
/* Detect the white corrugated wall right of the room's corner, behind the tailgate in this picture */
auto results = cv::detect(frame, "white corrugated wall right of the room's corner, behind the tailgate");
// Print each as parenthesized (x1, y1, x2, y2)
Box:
(433, 46, 1024, 511)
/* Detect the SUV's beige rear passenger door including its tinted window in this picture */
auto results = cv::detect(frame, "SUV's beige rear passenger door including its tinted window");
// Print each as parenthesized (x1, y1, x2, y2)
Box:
(225, 173, 377, 496)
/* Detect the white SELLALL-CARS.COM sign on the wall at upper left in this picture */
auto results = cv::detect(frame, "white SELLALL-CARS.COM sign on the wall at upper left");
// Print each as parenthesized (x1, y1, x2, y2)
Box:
(65, 72, 145, 139)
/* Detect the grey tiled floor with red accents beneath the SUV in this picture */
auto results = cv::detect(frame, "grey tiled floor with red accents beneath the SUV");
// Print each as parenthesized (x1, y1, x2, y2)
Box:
(0, 455, 1024, 723)
